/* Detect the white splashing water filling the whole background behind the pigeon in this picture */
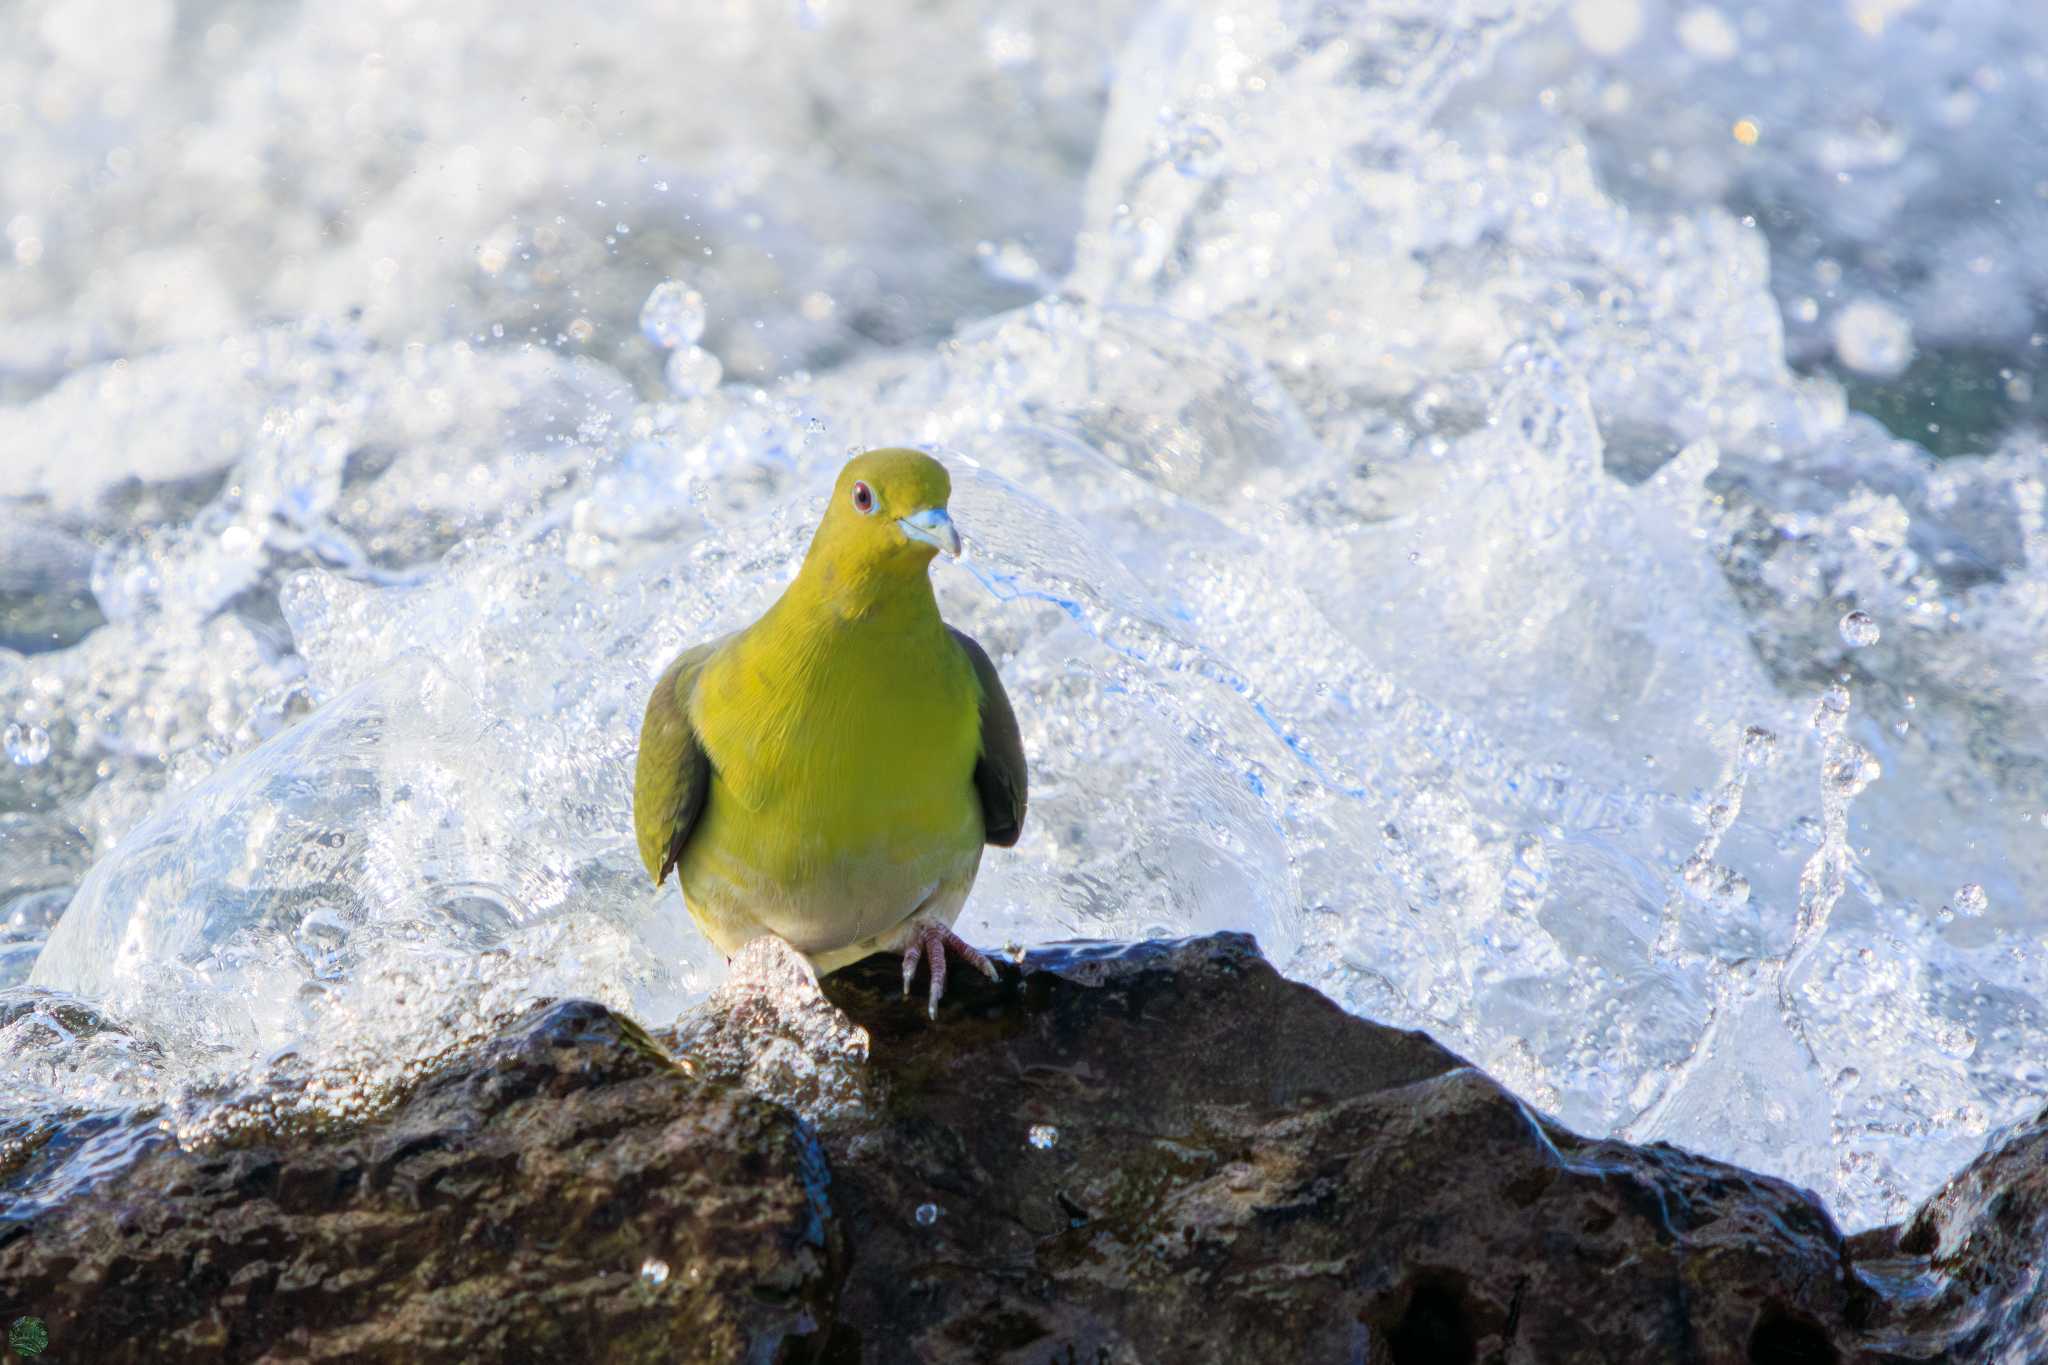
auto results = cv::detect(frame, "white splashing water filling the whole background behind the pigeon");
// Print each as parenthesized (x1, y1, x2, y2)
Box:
(0, 0, 2048, 1224)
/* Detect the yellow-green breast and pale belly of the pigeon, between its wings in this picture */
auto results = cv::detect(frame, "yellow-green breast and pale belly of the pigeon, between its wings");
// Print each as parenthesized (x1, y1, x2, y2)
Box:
(678, 575, 983, 970)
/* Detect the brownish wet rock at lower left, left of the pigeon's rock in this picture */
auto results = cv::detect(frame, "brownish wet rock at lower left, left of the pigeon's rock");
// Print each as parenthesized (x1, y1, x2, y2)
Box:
(0, 1003, 840, 1363)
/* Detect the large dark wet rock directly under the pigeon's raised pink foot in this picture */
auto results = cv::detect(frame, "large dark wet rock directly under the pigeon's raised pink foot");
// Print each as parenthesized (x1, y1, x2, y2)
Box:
(823, 935, 1868, 1365)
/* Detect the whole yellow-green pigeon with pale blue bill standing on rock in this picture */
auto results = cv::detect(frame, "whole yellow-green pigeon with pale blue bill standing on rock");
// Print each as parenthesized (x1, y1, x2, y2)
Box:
(633, 450, 1026, 1019)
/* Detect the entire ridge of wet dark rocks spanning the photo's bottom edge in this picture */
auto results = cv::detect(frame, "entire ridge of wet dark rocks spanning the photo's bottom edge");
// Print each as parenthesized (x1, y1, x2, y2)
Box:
(0, 935, 2048, 1365)
